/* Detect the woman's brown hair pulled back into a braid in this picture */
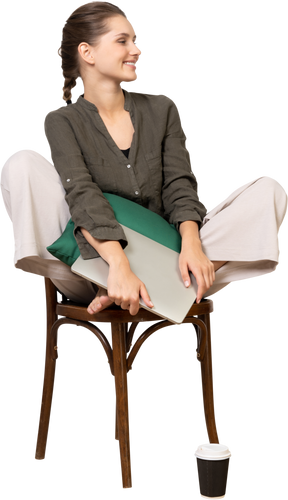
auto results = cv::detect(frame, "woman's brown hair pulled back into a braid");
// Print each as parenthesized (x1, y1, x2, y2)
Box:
(55, 0, 130, 103)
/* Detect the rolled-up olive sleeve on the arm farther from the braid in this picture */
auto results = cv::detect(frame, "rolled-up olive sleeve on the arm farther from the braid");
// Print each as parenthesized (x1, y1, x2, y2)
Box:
(162, 100, 207, 230)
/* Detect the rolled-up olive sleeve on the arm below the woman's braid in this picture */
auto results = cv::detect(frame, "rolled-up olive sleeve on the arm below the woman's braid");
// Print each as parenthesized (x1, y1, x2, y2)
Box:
(42, 110, 127, 259)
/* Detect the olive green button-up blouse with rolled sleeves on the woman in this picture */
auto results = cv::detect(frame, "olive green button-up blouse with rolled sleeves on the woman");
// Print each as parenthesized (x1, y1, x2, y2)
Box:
(42, 87, 208, 259)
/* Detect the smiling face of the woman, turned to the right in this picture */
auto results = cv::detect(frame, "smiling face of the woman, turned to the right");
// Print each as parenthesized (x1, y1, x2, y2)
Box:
(79, 16, 144, 84)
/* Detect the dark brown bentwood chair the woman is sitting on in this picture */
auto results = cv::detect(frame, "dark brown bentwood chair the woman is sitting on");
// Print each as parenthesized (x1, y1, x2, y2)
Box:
(32, 278, 222, 492)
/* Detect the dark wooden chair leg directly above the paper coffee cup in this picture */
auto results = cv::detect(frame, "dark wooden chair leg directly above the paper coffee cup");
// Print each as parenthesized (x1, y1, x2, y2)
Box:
(198, 314, 222, 443)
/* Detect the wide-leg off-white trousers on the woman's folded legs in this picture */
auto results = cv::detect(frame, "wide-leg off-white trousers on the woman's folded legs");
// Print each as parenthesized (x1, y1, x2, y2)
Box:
(0, 146, 288, 303)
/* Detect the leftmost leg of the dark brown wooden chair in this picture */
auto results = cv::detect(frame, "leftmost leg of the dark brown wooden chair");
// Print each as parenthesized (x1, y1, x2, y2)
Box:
(32, 278, 59, 463)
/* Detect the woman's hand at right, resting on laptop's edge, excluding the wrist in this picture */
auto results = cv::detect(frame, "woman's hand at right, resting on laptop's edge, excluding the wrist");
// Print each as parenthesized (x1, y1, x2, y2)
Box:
(179, 240, 215, 304)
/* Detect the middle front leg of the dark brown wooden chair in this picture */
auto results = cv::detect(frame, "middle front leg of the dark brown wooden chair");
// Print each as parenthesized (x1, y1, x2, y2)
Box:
(109, 323, 135, 492)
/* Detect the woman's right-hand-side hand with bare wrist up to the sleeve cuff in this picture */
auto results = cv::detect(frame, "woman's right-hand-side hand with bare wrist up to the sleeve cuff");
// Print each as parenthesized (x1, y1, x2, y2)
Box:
(179, 221, 215, 304)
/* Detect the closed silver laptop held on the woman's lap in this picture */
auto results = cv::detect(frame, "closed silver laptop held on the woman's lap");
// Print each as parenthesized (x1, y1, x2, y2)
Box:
(71, 224, 197, 325)
